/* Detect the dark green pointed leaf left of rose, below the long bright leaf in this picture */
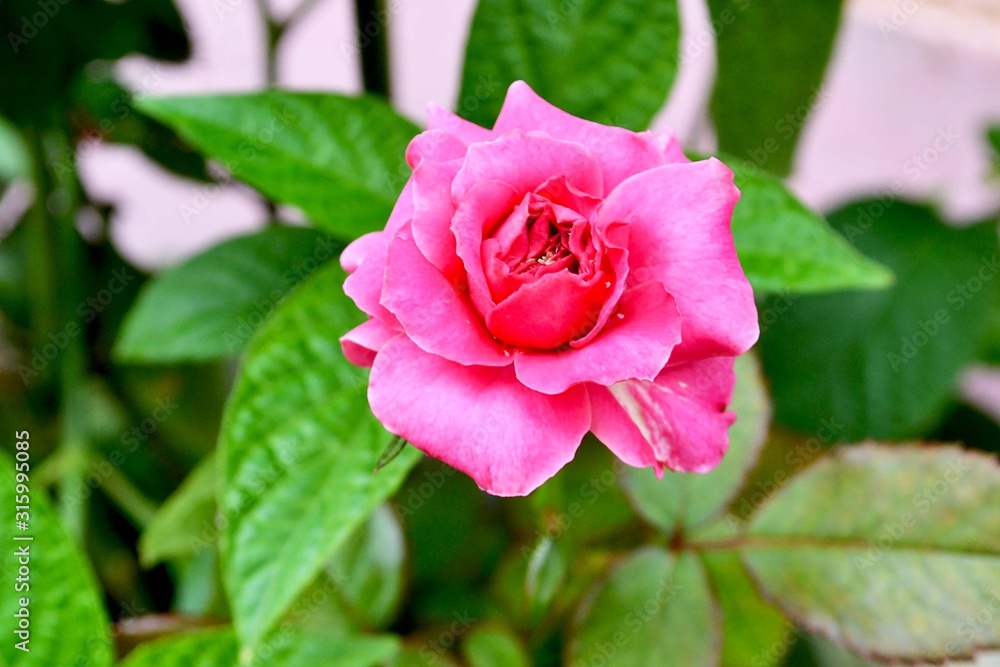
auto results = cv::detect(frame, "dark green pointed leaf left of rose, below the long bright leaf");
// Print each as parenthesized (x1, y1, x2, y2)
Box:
(115, 227, 341, 363)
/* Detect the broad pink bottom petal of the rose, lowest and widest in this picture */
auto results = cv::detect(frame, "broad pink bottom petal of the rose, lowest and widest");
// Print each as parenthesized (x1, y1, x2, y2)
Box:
(368, 336, 590, 496)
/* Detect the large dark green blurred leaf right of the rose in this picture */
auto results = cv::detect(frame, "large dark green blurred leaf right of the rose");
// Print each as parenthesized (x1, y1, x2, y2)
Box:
(759, 201, 1000, 442)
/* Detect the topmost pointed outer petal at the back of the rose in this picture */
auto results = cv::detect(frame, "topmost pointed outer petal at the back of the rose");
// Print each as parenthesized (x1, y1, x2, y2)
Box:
(493, 81, 683, 192)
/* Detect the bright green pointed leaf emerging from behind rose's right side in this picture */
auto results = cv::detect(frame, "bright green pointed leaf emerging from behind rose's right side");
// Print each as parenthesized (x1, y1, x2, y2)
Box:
(722, 156, 893, 294)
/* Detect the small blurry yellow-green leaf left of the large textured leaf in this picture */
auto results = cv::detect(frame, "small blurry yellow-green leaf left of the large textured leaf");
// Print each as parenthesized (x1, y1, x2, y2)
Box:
(139, 454, 217, 567)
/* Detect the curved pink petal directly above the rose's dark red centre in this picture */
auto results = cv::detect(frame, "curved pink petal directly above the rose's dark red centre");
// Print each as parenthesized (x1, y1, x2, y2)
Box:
(452, 130, 604, 202)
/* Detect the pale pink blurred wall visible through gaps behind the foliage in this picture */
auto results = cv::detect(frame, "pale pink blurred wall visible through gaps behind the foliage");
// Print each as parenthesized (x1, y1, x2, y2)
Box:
(48, 0, 1000, 665)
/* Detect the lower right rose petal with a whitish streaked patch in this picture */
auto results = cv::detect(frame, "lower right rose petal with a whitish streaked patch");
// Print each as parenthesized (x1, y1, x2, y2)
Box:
(588, 357, 736, 473)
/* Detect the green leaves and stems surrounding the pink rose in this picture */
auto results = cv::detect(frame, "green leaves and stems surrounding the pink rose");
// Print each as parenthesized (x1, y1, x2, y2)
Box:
(0, 0, 1000, 667)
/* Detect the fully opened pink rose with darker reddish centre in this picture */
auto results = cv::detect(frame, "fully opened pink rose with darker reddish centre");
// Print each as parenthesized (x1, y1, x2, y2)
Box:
(341, 82, 758, 496)
